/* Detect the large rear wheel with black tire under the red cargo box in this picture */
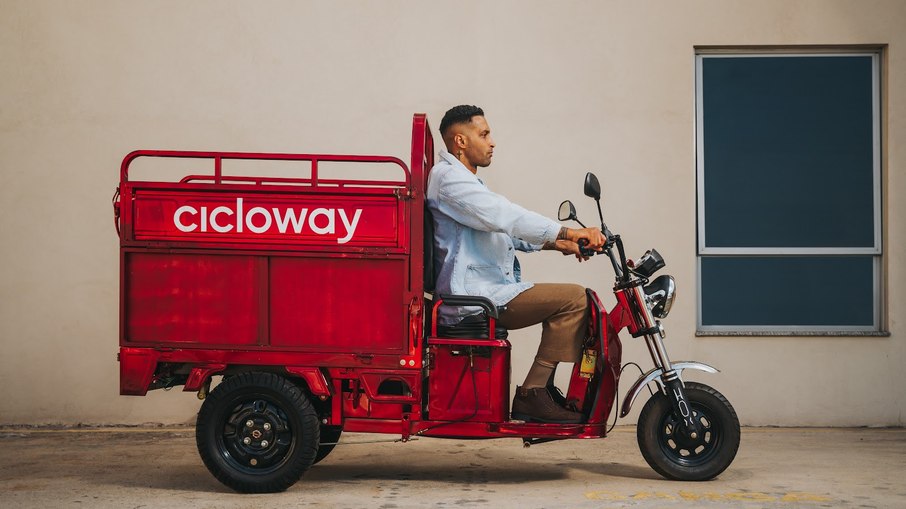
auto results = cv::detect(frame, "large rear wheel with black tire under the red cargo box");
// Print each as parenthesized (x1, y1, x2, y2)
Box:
(195, 373, 320, 493)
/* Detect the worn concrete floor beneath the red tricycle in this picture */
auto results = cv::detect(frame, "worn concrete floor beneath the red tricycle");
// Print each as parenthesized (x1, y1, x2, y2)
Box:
(0, 427, 906, 509)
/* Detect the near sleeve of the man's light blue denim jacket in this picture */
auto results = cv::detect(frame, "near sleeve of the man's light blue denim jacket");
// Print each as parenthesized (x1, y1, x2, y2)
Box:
(438, 171, 560, 245)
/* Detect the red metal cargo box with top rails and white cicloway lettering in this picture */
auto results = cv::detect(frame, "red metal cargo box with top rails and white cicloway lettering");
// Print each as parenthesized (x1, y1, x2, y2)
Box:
(115, 116, 433, 378)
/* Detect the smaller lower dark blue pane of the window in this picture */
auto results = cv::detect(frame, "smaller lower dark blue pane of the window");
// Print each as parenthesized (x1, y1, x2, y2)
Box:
(701, 255, 874, 327)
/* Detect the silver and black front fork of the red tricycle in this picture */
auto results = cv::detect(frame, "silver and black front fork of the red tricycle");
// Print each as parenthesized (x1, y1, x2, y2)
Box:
(618, 282, 701, 438)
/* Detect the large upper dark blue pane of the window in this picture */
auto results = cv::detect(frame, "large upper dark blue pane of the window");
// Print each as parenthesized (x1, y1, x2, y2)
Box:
(701, 55, 875, 247)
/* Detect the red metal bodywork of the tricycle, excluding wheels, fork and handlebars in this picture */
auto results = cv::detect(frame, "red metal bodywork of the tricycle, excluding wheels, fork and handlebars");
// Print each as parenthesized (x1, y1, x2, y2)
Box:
(114, 114, 631, 439)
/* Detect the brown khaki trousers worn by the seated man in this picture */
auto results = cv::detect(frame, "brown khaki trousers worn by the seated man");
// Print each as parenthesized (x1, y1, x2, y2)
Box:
(497, 283, 588, 362)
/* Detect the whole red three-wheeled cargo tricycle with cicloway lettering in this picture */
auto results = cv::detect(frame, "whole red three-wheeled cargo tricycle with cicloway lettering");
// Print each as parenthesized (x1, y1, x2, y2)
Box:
(114, 114, 739, 492)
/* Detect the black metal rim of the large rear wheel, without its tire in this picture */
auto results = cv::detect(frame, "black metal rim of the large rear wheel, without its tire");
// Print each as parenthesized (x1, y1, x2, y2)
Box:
(216, 396, 296, 475)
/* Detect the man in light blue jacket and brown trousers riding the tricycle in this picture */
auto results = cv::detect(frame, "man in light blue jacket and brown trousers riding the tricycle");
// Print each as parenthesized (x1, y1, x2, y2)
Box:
(427, 105, 605, 423)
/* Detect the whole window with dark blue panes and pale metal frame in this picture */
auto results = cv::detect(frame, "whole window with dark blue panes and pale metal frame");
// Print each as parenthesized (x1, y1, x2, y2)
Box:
(696, 51, 881, 334)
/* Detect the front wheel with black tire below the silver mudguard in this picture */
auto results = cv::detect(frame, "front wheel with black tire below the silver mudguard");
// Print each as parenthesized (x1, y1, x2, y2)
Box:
(637, 382, 739, 481)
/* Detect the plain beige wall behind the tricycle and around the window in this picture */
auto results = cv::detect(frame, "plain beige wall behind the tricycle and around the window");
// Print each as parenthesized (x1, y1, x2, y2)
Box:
(0, 0, 906, 425)
